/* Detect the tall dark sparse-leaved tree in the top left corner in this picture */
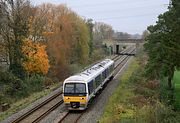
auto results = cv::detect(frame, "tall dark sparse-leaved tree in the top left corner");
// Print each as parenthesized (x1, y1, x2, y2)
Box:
(0, 0, 30, 77)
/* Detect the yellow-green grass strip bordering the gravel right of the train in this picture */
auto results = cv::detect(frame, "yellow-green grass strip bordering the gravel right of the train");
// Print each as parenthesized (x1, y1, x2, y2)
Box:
(100, 58, 138, 123)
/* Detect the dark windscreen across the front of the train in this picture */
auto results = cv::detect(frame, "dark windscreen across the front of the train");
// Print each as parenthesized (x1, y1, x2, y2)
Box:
(64, 83, 86, 96)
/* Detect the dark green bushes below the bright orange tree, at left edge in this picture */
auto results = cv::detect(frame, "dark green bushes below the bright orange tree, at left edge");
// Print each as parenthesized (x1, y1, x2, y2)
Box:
(0, 72, 45, 103)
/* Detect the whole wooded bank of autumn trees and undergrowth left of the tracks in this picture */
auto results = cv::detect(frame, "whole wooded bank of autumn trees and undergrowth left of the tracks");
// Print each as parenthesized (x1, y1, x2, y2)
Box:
(0, 0, 113, 120)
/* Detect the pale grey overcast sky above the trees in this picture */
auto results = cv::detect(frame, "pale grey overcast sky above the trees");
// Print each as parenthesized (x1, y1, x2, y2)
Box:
(31, 0, 169, 34)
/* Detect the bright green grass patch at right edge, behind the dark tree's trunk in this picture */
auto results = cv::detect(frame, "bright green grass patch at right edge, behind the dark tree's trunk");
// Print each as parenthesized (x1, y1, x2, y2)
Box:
(173, 71, 180, 110)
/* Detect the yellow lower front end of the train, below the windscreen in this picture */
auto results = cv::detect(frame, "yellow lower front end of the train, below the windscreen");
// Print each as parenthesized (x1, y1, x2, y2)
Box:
(63, 96, 88, 110)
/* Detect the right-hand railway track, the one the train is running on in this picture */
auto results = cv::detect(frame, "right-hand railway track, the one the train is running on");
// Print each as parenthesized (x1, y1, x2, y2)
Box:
(58, 48, 135, 123)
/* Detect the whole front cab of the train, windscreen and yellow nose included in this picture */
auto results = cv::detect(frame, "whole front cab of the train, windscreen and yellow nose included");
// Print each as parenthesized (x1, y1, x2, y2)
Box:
(63, 76, 88, 110)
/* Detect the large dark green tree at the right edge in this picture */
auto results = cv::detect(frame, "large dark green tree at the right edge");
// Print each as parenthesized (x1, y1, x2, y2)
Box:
(145, 0, 180, 88)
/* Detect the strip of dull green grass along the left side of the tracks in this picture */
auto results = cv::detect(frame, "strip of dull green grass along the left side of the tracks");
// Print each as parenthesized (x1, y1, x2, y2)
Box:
(0, 83, 60, 121)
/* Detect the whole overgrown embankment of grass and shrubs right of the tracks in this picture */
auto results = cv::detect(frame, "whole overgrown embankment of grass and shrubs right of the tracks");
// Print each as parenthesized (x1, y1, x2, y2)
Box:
(99, 52, 180, 123)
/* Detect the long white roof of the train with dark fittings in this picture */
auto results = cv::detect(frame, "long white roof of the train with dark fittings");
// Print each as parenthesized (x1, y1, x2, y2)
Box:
(65, 59, 114, 83)
